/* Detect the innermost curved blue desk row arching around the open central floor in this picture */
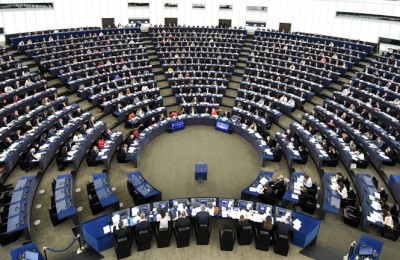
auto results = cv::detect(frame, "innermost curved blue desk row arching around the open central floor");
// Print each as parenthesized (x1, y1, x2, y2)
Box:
(126, 114, 274, 167)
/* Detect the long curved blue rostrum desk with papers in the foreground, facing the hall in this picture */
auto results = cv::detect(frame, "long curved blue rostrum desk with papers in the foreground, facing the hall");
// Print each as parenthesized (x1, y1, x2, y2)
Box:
(82, 198, 321, 252)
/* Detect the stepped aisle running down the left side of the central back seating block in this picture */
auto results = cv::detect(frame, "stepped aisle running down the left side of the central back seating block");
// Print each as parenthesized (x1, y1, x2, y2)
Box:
(142, 31, 179, 113)
